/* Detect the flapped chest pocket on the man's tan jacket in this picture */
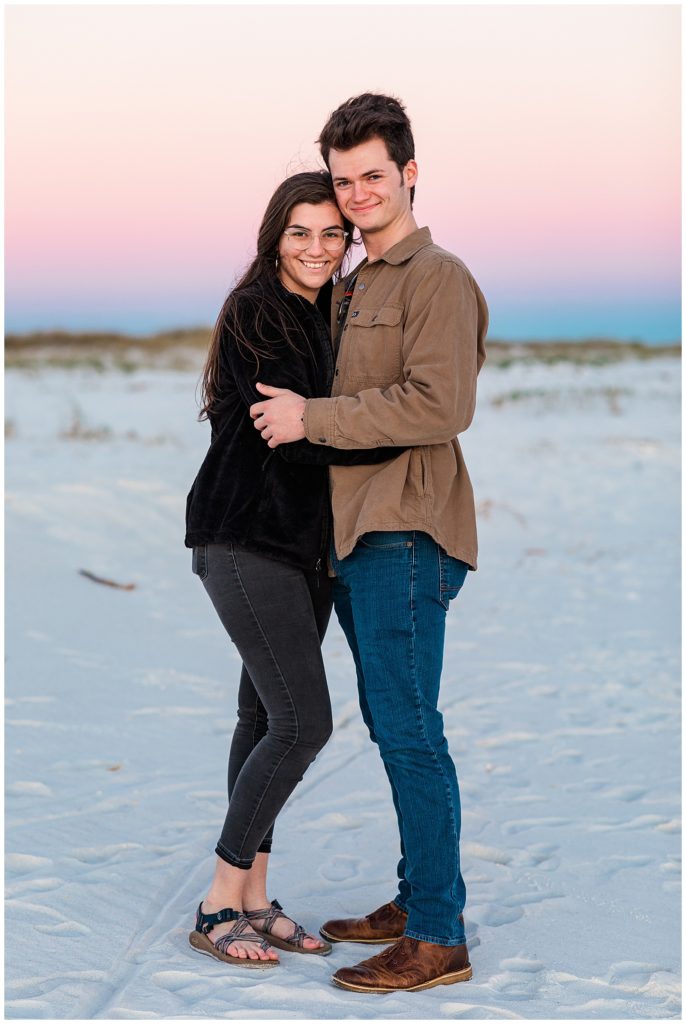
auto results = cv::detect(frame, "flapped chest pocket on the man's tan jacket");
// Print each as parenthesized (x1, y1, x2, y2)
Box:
(345, 306, 402, 387)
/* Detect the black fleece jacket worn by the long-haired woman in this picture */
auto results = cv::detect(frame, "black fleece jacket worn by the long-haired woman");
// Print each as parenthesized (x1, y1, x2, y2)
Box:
(185, 281, 403, 569)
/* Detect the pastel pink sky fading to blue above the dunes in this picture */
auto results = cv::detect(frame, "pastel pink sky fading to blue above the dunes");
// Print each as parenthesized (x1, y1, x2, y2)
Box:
(5, 5, 680, 340)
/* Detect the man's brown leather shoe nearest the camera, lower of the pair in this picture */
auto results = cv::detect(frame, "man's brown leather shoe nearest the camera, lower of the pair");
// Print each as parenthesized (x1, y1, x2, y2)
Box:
(332, 935, 472, 992)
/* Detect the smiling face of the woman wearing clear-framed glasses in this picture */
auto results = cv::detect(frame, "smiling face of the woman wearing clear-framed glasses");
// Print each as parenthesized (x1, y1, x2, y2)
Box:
(278, 203, 345, 302)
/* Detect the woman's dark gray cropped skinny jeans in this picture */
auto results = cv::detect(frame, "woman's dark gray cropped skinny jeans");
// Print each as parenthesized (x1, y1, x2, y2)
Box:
(192, 544, 333, 869)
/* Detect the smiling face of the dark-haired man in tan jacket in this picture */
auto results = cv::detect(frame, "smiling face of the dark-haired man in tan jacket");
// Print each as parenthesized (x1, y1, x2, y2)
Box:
(329, 138, 417, 234)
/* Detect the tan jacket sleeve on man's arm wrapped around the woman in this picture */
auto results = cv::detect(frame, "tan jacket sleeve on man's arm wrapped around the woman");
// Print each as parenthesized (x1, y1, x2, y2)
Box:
(304, 260, 488, 450)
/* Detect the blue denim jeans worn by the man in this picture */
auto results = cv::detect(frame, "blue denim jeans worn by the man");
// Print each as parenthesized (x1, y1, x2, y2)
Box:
(331, 530, 468, 946)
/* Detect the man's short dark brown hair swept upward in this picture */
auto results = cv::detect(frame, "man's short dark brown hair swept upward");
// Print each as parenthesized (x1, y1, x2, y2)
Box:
(317, 92, 415, 203)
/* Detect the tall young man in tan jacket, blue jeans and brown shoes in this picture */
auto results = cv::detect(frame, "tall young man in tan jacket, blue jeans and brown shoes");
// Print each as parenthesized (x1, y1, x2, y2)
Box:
(251, 93, 487, 991)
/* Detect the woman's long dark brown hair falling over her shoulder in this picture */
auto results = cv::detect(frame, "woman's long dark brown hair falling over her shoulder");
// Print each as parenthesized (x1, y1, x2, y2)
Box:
(199, 171, 352, 420)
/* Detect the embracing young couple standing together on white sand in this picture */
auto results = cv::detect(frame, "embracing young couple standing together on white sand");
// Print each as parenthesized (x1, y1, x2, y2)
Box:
(185, 93, 487, 992)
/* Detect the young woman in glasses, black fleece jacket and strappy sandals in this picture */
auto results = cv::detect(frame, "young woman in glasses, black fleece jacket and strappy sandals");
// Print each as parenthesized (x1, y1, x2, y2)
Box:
(185, 171, 400, 968)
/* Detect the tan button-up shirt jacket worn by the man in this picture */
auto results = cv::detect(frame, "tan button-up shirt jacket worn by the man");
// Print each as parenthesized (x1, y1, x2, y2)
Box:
(304, 227, 488, 568)
